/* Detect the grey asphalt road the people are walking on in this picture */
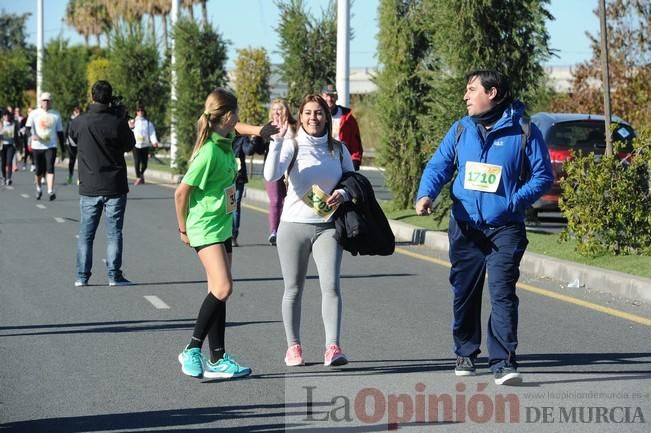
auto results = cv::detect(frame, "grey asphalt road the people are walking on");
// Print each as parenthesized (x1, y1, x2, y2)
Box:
(0, 170, 651, 433)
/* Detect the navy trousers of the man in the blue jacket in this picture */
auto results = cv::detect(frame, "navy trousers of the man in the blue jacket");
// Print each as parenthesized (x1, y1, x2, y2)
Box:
(448, 217, 528, 371)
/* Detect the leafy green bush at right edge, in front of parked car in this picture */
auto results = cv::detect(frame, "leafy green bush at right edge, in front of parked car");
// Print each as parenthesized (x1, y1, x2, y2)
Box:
(559, 130, 651, 257)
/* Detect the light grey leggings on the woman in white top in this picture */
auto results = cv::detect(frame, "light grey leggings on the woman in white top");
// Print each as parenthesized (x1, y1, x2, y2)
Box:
(277, 221, 343, 347)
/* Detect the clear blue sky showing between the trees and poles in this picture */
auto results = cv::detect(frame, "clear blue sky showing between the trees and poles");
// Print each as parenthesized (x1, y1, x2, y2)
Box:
(0, 0, 599, 67)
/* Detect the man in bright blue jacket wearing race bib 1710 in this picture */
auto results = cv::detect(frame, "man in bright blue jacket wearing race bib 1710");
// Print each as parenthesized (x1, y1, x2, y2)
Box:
(416, 70, 553, 385)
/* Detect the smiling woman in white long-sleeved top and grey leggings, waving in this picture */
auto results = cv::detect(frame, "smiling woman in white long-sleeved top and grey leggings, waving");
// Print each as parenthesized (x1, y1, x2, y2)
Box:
(264, 95, 354, 366)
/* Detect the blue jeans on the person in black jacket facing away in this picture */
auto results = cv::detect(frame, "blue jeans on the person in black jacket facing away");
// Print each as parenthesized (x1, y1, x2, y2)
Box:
(77, 194, 127, 281)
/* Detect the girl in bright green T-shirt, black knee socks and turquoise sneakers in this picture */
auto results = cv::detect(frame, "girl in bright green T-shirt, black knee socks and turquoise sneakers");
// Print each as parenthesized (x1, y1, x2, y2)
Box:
(174, 88, 251, 379)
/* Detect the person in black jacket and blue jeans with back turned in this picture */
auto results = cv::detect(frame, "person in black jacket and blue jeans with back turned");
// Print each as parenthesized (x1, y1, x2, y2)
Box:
(70, 80, 136, 287)
